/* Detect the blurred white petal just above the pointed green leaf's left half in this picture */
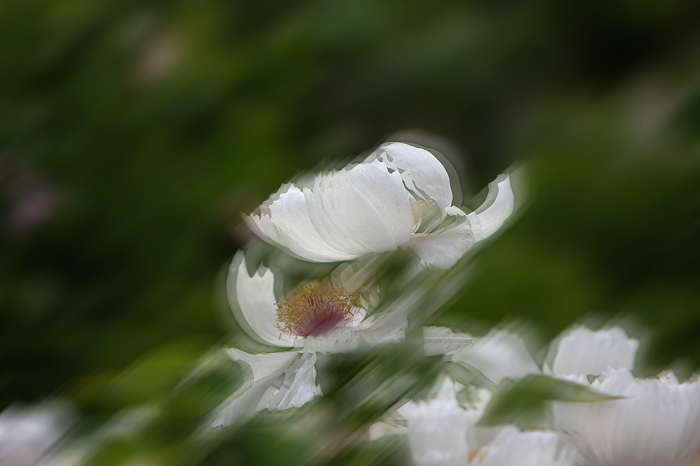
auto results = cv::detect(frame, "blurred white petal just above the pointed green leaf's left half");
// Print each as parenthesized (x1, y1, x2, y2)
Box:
(451, 330, 541, 384)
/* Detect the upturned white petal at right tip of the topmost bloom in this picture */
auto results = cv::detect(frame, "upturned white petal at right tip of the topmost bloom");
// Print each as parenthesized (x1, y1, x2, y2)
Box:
(467, 175, 515, 241)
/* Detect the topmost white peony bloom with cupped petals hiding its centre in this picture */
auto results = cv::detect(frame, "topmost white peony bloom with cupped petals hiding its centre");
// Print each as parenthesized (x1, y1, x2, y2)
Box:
(246, 142, 514, 268)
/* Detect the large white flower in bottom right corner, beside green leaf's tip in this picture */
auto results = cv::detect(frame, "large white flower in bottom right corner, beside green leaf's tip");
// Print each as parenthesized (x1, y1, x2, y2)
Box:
(554, 369, 700, 466)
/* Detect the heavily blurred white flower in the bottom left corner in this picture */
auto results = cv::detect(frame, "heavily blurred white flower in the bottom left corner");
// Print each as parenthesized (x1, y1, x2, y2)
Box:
(0, 404, 75, 466)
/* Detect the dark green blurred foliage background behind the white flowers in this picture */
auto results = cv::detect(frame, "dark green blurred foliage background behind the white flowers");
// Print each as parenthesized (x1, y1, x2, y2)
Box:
(0, 0, 700, 464)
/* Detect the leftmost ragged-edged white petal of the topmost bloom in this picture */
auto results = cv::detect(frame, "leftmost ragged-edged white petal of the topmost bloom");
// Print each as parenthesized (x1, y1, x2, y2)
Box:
(245, 185, 355, 262)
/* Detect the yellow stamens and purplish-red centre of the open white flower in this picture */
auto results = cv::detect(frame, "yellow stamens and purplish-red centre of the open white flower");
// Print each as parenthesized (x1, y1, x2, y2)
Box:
(277, 282, 353, 337)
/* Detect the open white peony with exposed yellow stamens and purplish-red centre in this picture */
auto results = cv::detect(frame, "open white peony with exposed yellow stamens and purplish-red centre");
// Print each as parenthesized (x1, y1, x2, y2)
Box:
(214, 252, 415, 426)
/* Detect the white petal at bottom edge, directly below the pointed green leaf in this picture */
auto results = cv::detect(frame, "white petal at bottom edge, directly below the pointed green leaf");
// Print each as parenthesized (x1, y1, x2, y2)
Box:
(475, 426, 578, 466)
